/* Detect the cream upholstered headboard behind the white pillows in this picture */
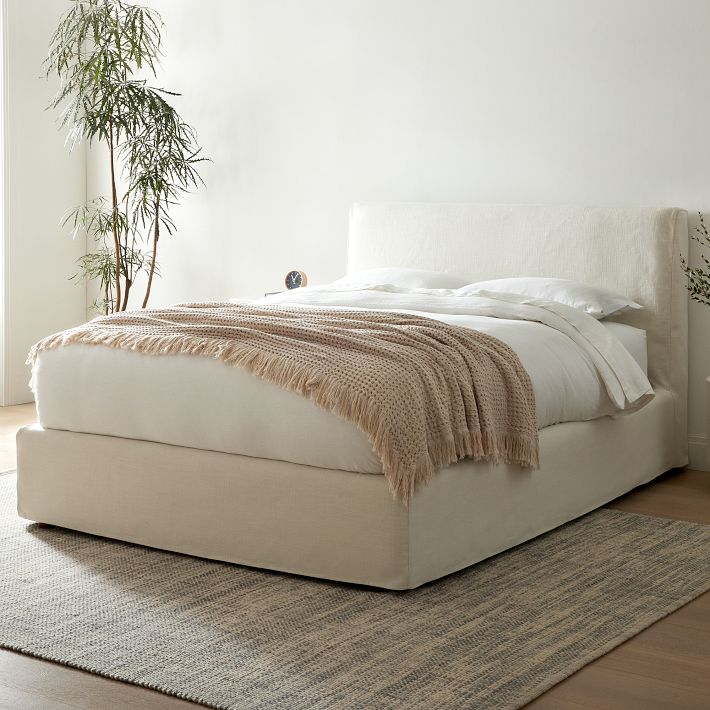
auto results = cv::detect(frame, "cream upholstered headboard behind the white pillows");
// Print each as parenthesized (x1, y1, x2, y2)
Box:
(347, 203, 688, 436)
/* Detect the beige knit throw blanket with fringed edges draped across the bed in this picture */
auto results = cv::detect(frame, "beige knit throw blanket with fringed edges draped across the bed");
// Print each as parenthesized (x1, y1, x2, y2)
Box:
(28, 302, 538, 502)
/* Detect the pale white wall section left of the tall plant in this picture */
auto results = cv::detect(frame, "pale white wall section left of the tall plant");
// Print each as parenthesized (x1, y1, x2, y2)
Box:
(0, 0, 86, 404)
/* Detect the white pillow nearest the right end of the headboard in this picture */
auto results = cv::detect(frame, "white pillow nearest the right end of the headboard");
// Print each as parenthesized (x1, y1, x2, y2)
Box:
(460, 276, 643, 320)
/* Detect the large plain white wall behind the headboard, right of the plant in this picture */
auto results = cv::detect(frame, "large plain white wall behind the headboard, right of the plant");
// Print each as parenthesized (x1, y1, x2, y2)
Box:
(89, 0, 710, 468)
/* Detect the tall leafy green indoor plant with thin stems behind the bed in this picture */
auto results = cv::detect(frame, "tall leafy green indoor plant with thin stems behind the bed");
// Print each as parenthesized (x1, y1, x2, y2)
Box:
(46, 0, 205, 313)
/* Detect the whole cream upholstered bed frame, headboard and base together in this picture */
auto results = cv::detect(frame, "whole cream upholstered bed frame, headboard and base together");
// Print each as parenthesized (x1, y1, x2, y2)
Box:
(17, 204, 687, 589)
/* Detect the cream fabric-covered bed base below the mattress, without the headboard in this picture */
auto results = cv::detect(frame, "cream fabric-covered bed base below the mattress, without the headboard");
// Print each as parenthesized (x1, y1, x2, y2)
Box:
(17, 390, 686, 589)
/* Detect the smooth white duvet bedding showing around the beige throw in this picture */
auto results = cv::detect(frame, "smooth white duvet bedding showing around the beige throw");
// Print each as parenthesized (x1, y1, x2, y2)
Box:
(33, 286, 653, 473)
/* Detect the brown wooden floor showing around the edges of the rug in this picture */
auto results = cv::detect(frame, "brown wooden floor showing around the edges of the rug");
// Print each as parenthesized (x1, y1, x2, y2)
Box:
(0, 405, 710, 710)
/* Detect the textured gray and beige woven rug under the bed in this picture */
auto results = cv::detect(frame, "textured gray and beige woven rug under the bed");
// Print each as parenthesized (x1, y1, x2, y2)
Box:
(0, 475, 710, 710)
